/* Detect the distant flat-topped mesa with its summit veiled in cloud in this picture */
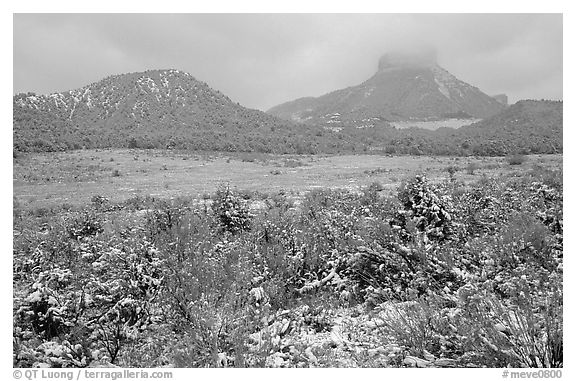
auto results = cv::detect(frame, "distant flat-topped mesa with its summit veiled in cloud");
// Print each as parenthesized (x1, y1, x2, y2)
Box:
(268, 53, 504, 124)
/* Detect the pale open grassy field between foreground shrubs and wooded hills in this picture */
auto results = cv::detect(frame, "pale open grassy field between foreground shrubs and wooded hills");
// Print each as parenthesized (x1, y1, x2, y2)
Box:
(13, 149, 562, 209)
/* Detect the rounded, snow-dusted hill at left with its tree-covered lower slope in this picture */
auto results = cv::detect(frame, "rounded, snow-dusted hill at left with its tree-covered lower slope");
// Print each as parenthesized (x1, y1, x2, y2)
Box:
(13, 70, 354, 153)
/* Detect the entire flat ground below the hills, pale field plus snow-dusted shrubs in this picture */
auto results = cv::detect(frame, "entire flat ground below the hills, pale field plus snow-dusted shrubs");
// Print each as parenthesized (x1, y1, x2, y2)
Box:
(13, 150, 563, 367)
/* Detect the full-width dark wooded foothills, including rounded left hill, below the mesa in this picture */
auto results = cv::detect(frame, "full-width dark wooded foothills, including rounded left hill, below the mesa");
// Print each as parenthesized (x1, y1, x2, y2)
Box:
(13, 69, 562, 155)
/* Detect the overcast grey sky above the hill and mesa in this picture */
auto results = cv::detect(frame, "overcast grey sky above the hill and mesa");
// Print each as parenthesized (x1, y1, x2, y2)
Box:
(13, 14, 562, 110)
